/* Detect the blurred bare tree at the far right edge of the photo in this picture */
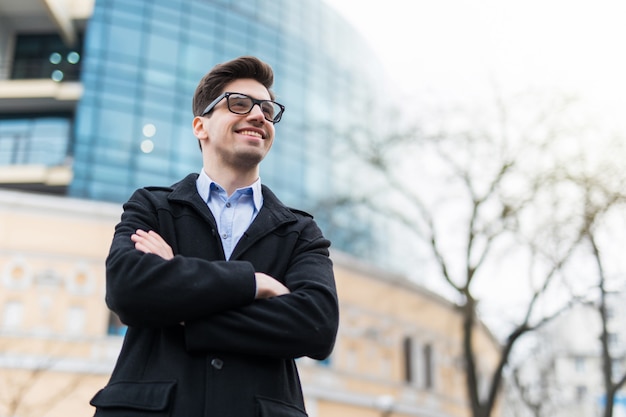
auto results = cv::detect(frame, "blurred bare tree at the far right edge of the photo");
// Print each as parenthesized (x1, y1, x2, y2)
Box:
(490, 132, 626, 417)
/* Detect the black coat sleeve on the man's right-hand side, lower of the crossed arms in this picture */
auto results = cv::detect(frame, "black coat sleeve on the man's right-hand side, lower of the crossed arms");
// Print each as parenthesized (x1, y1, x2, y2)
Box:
(185, 222, 339, 359)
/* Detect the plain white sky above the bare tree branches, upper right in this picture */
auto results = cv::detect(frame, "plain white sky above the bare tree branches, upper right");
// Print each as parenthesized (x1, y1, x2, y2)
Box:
(325, 0, 626, 132)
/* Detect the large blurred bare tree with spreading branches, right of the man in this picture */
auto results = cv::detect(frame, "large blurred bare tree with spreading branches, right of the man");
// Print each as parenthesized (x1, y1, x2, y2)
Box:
(316, 90, 600, 417)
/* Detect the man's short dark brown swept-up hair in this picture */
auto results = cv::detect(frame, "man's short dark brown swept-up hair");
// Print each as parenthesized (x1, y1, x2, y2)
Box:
(193, 56, 274, 116)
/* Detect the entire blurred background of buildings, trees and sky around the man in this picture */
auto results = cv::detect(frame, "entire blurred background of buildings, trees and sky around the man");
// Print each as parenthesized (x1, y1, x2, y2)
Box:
(0, 0, 626, 417)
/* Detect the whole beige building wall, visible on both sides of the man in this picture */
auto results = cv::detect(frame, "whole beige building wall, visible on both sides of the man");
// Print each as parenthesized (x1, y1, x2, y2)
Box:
(0, 191, 496, 417)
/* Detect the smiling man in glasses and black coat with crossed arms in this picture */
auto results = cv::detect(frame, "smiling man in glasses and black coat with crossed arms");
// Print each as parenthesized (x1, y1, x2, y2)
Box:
(91, 57, 338, 417)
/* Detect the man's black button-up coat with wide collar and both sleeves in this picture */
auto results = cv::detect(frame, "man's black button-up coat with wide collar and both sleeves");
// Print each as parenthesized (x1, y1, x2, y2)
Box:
(91, 174, 339, 417)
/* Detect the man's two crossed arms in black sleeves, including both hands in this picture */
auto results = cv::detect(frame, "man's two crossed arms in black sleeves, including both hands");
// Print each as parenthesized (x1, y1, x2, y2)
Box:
(114, 219, 339, 359)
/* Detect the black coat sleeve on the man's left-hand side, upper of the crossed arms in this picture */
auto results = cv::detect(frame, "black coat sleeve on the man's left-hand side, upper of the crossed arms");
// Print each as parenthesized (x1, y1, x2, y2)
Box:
(106, 190, 256, 327)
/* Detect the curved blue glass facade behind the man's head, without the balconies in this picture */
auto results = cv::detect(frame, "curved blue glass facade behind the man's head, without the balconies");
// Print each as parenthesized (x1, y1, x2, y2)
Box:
(70, 0, 382, 209)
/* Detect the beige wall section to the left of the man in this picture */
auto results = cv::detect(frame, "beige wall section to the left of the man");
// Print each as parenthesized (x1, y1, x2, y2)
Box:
(0, 191, 120, 417)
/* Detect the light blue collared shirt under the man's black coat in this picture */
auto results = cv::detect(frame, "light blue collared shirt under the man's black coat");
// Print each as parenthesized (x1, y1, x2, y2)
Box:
(196, 170, 263, 259)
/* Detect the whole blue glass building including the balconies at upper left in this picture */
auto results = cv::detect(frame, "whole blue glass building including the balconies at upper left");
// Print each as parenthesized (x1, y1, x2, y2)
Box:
(0, 0, 383, 262)
